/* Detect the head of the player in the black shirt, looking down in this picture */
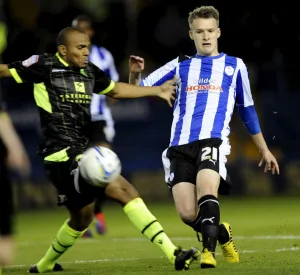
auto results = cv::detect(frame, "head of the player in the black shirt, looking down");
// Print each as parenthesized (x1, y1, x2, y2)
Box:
(65, 32, 90, 68)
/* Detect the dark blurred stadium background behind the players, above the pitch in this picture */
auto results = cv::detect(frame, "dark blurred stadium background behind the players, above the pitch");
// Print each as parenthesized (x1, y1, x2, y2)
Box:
(2, 0, 300, 210)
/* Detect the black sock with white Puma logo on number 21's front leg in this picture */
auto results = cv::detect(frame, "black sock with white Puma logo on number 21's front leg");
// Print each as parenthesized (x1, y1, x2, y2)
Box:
(198, 195, 220, 252)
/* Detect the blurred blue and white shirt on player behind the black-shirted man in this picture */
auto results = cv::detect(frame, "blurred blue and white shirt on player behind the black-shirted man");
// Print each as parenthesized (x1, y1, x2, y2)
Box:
(89, 45, 119, 124)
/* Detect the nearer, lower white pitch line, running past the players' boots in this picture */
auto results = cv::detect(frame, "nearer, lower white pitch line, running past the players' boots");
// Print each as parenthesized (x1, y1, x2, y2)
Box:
(7, 247, 300, 268)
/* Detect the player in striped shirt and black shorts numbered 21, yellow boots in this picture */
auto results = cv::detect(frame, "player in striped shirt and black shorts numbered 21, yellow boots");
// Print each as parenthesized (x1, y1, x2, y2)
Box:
(129, 6, 279, 268)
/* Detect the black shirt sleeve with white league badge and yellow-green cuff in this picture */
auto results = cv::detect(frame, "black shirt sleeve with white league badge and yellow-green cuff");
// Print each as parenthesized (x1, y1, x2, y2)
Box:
(8, 55, 48, 83)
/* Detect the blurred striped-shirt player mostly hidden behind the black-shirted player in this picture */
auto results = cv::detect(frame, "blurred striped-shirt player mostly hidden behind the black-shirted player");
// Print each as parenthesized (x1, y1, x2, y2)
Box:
(72, 15, 119, 237)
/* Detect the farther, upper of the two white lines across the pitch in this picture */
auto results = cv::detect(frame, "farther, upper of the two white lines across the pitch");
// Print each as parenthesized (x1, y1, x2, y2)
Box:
(17, 235, 300, 246)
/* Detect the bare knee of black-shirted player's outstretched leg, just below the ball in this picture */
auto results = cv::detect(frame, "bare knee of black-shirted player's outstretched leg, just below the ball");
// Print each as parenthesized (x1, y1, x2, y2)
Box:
(105, 176, 139, 205)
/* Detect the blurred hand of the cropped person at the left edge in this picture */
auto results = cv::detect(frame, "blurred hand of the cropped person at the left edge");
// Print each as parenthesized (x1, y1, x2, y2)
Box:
(7, 148, 31, 177)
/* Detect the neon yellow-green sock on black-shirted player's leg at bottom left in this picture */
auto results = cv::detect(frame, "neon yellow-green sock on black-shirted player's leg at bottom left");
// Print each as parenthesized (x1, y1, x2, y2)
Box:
(37, 220, 84, 273)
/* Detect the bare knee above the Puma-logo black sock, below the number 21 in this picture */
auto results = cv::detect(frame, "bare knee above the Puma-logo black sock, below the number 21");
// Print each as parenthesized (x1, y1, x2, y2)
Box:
(196, 169, 220, 200)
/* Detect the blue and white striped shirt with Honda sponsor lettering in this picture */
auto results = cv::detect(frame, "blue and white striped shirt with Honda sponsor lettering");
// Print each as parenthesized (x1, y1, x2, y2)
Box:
(140, 53, 260, 149)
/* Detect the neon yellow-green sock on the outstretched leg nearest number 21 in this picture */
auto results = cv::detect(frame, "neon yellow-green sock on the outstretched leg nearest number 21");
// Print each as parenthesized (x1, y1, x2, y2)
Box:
(124, 198, 176, 264)
